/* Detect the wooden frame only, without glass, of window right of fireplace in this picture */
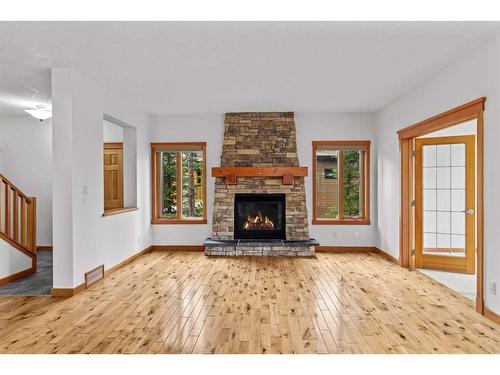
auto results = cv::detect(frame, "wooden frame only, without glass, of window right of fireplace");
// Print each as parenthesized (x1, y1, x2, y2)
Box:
(312, 140, 371, 225)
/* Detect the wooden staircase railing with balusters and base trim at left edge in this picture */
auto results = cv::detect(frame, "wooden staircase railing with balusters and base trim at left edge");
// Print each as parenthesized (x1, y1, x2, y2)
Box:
(0, 174, 36, 285)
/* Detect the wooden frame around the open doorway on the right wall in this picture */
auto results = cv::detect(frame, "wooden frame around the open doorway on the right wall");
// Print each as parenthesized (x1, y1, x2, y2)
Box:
(397, 97, 486, 315)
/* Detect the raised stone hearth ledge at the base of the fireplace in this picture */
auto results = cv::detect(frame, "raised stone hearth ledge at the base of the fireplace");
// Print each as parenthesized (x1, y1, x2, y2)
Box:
(204, 238, 319, 256)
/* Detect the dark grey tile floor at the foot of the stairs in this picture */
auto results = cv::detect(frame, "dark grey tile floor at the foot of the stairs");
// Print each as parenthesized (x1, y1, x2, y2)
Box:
(0, 250, 52, 296)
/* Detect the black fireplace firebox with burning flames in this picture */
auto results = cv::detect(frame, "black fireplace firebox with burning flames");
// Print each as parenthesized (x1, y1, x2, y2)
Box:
(234, 194, 286, 240)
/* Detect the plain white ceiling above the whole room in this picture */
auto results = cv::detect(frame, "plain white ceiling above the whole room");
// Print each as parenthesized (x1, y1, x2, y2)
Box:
(0, 22, 500, 114)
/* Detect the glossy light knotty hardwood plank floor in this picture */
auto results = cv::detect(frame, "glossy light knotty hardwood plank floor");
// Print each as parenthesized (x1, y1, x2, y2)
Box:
(0, 251, 500, 353)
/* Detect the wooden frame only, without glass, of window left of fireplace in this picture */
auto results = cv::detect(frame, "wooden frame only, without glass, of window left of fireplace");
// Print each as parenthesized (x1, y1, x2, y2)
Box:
(151, 142, 207, 224)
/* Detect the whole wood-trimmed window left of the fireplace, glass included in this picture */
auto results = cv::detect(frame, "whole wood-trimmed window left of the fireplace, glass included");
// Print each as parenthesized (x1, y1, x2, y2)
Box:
(151, 142, 207, 224)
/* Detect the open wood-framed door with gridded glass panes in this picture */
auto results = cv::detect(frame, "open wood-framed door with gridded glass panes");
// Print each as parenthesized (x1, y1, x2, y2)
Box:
(415, 136, 475, 273)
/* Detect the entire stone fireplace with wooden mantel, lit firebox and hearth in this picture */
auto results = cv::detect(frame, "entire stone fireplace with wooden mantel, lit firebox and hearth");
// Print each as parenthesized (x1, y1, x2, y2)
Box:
(205, 112, 317, 256)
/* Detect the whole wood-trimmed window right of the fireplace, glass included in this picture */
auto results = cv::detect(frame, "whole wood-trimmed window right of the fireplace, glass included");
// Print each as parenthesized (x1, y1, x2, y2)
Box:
(312, 141, 370, 224)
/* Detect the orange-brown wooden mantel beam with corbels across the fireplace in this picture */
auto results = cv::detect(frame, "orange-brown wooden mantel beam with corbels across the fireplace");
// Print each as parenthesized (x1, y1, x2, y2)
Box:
(212, 167, 307, 185)
